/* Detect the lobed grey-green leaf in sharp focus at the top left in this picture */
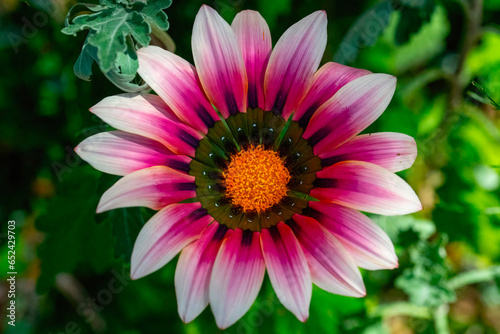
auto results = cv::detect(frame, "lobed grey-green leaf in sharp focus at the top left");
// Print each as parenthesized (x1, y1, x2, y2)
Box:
(62, 0, 172, 92)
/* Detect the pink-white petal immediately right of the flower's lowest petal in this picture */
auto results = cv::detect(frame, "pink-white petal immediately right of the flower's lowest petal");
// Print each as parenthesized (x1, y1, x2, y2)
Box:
(261, 223, 312, 322)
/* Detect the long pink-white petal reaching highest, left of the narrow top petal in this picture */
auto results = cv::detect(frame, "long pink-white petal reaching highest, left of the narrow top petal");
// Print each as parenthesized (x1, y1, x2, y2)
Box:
(191, 5, 248, 118)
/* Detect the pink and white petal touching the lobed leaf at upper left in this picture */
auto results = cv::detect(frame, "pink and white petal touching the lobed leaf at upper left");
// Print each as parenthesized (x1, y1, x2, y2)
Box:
(137, 46, 219, 133)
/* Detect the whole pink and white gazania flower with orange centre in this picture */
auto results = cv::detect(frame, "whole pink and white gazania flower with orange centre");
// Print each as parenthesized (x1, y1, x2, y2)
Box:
(76, 6, 421, 328)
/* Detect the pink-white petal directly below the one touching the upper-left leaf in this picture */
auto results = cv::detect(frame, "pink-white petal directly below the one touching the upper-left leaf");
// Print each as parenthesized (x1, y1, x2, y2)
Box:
(90, 94, 202, 155)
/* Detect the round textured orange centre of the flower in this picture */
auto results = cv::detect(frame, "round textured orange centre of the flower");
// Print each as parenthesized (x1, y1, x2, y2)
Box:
(223, 145, 290, 213)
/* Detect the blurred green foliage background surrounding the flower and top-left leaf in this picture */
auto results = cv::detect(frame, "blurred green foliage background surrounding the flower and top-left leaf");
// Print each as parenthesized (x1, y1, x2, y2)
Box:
(0, 0, 500, 334)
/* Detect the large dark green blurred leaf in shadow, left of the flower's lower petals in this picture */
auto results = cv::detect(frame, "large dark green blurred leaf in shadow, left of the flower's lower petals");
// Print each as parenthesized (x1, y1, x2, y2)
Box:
(36, 165, 114, 293)
